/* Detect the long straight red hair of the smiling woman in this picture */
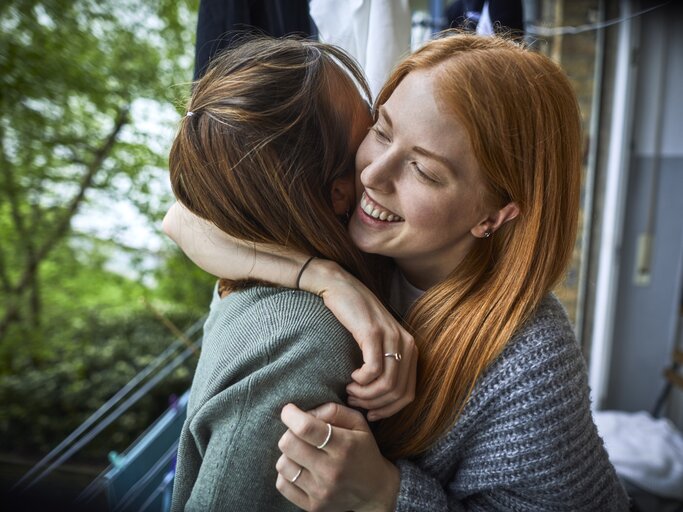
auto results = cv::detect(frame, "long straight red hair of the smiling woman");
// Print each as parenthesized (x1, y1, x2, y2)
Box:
(377, 34, 581, 457)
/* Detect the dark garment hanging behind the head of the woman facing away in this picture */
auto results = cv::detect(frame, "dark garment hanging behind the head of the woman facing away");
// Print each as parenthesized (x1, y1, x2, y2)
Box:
(194, 0, 317, 80)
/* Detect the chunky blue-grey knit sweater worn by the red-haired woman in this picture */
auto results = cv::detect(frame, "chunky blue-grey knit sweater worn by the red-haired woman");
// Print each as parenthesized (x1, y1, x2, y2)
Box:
(396, 296, 628, 512)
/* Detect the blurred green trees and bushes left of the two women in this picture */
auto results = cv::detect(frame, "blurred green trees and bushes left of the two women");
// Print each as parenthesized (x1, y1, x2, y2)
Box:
(0, 0, 218, 459)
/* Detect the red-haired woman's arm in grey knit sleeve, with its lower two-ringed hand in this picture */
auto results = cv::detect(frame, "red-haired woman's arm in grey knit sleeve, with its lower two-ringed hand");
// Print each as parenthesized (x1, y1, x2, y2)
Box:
(276, 314, 629, 512)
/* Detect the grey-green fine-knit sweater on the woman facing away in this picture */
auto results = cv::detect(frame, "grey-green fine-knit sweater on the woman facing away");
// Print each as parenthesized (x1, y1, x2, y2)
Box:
(171, 286, 362, 512)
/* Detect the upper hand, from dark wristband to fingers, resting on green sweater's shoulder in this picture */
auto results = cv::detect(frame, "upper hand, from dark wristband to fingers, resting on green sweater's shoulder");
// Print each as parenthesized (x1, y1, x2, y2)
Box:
(301, 259, 418, 421)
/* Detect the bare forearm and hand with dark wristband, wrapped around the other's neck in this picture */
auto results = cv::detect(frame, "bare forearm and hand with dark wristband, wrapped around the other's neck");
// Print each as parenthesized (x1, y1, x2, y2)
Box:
(163, 203, 417, 421)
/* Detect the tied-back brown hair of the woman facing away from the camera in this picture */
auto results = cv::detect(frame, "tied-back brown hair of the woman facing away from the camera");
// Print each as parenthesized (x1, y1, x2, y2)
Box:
(169, 37, 384, 289)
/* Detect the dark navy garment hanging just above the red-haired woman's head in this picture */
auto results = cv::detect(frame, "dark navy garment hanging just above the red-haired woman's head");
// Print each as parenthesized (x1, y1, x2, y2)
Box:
(446, 0, 524, 34)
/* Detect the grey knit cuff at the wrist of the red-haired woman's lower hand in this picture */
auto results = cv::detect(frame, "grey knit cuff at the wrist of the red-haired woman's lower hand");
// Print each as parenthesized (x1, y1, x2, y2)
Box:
(396, 460, 448, 512)
